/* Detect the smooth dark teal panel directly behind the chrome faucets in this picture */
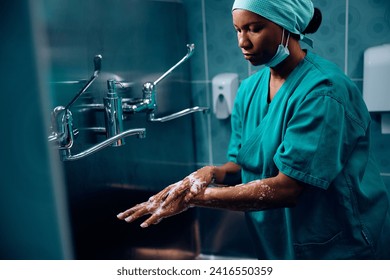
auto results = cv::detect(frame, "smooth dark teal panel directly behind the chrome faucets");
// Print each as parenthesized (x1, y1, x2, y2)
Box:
(42, 0, 195, 194)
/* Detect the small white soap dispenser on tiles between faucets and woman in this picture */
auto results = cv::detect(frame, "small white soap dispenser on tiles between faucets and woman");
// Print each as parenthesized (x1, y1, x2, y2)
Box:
(212, 73, 238, 119)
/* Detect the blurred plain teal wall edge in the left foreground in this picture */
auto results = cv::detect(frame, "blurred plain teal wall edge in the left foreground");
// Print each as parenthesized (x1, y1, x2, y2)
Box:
(0, 0, 72, 259)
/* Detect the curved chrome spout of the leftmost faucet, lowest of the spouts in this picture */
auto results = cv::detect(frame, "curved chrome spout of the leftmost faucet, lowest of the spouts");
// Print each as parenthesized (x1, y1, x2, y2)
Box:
(61, 128, 146, 161)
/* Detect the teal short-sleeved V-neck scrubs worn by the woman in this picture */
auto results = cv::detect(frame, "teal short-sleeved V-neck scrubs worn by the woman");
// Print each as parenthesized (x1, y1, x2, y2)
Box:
(228, 52, 390, 259)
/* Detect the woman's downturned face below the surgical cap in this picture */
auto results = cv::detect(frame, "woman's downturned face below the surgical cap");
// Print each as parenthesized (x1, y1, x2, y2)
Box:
(233, 9, 283, 66)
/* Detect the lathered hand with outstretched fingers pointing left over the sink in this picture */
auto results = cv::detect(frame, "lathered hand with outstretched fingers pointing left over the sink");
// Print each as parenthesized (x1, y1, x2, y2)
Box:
(117, 166, 214, 228)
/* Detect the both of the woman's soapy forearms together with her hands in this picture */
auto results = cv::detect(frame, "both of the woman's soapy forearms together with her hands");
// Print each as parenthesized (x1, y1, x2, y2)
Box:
(117, 167, 303, 227)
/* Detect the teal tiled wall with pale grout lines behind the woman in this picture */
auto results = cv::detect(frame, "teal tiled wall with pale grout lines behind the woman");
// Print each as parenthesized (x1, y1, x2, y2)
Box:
(183, 0, 390, 186)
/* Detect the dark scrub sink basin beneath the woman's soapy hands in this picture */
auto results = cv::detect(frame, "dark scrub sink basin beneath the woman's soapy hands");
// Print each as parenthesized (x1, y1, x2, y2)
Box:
(70, 187, 199, 260)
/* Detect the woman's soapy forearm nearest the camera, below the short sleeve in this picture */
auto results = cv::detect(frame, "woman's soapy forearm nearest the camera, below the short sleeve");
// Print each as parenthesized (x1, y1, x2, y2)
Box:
(191, 174, 303, 211)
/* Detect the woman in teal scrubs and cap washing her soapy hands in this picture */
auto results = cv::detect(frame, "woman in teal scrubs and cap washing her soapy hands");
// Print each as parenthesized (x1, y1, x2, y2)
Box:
(118, 0, 390, 259)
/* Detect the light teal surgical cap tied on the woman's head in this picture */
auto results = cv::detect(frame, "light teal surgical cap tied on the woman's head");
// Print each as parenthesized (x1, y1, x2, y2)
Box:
(232, 0, 314, 46)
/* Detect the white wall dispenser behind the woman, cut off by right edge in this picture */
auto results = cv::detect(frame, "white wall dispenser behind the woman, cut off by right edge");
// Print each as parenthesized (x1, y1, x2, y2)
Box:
(363, 44, 390, 133)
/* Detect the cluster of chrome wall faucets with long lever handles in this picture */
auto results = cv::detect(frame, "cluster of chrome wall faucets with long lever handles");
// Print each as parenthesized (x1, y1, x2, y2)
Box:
(48, 44, 209, 161)
